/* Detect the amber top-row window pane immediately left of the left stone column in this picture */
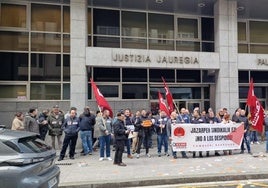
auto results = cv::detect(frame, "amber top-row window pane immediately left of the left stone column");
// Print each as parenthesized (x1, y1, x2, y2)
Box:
(31, 4, 61, 32)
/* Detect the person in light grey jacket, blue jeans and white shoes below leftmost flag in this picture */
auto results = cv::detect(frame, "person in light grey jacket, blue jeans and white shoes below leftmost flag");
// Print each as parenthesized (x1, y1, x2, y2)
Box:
(96, 110, 112, 161)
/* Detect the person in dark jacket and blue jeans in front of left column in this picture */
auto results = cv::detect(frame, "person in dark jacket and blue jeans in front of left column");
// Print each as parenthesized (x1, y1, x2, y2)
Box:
(79, 106, 96, 155)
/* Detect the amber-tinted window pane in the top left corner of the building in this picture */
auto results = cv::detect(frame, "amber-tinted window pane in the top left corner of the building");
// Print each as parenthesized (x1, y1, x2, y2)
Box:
(0, 3, 26, 28)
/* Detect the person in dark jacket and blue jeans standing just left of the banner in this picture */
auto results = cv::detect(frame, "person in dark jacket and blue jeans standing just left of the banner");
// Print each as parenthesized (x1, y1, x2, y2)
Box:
(155, 110, 169, 157)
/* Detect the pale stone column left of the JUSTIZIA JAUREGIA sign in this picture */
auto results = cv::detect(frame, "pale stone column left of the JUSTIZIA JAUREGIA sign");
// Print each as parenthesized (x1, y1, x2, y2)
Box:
(70, 0, 88, 113)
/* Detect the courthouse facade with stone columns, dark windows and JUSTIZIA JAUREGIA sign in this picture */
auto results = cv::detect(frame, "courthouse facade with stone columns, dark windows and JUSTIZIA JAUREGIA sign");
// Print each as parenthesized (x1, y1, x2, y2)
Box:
(0, 0, 268, 125)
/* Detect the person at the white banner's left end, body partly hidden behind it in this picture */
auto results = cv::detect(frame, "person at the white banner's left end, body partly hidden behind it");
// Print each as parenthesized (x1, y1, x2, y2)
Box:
(167, 112, 188, 159)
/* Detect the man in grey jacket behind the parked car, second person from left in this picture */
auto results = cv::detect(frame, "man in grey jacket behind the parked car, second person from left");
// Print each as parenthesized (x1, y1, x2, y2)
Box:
(24, 108, 39, 134)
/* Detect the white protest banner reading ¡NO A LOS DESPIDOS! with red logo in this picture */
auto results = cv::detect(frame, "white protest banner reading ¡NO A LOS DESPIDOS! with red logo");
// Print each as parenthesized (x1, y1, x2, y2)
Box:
(171, 123, 244, 151)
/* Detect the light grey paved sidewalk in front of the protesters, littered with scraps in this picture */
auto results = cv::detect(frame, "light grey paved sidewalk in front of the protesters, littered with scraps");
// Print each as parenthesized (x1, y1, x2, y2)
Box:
(56, 143, 268, 188)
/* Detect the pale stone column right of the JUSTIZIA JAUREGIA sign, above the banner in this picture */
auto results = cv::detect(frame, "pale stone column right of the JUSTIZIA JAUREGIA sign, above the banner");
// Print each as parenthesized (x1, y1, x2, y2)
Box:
(214, 0, 239, 113)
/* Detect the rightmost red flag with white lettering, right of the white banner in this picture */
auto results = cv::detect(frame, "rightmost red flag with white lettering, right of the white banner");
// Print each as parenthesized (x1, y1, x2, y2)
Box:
(247, 79, 264, 132)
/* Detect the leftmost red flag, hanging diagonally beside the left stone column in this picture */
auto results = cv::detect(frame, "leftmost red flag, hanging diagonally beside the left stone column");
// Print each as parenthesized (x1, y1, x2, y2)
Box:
(90, 79, 113, 117)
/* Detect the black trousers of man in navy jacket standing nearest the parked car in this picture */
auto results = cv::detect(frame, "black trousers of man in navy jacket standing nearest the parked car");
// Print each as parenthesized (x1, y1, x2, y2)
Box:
(60, 135, 78, 159)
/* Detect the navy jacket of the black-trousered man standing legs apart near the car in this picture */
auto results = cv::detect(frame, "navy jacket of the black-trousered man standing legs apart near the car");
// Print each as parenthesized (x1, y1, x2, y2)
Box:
(62, 117, 80, 136)
